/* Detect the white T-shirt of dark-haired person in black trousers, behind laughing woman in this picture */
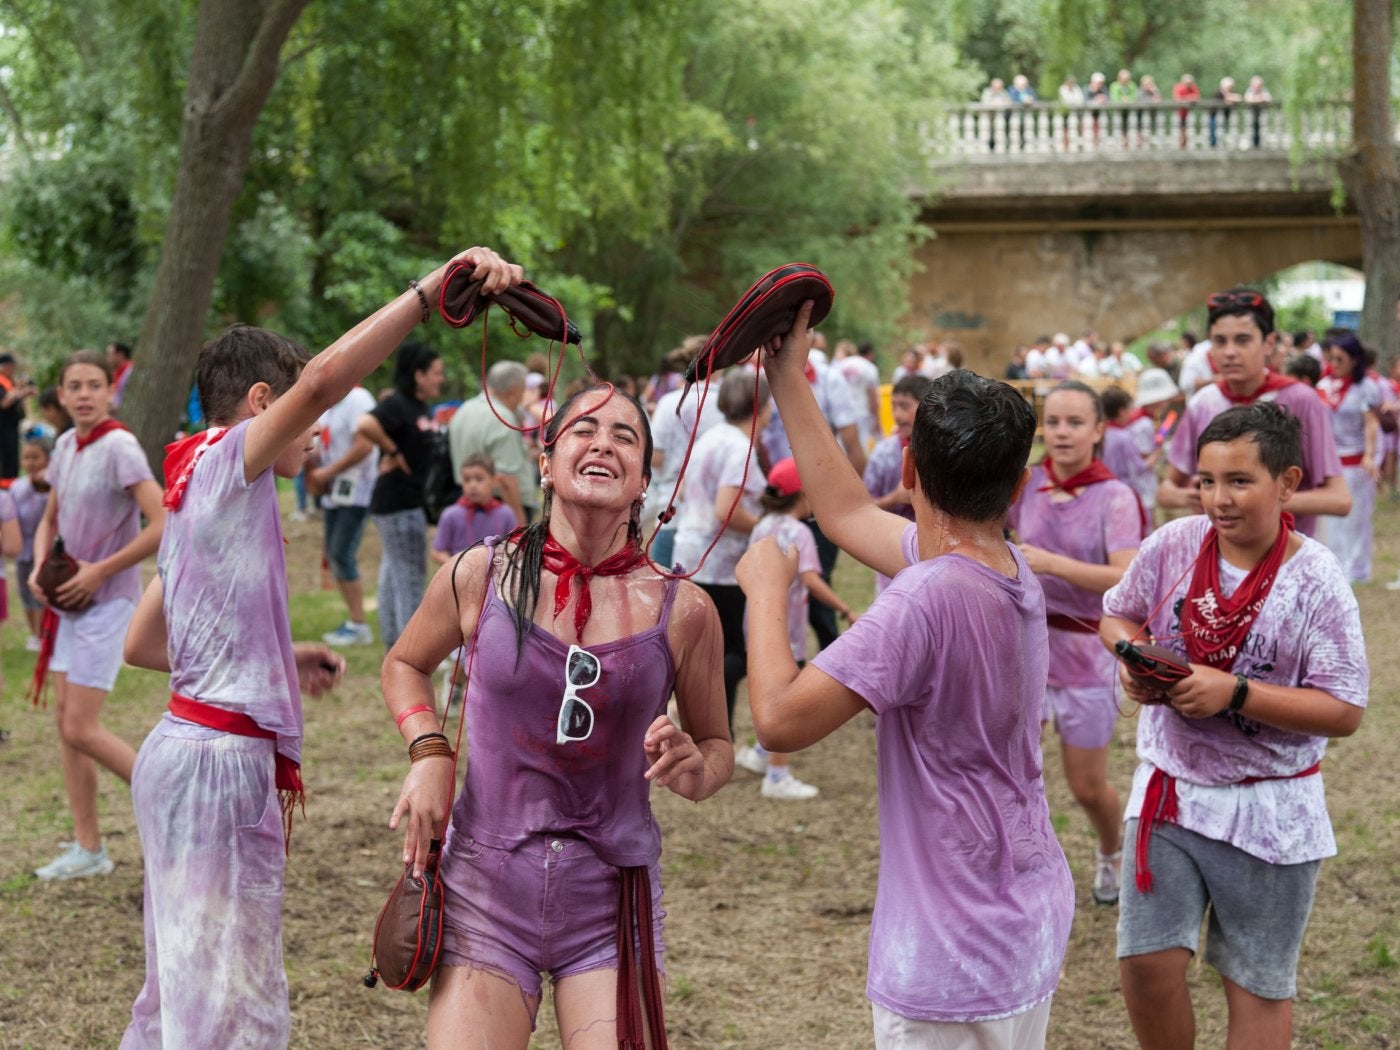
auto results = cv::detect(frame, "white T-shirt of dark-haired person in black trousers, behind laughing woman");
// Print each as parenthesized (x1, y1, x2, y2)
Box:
(675, 423, 767, 587)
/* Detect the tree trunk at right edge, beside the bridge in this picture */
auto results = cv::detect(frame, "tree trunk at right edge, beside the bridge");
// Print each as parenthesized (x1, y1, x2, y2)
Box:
(1341, 0, 1400, 358)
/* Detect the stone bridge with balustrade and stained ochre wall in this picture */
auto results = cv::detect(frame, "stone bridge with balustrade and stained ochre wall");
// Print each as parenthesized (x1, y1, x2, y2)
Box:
(909, 102, 1388, 374)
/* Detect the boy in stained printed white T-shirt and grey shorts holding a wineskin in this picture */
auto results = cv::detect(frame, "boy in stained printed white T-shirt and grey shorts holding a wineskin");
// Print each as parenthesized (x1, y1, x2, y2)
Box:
(1100, 402, 1369, 1049)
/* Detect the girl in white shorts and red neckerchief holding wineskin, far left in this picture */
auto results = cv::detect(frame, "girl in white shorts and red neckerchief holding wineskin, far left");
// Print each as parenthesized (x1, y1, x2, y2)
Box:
(29, 350, 165, 879)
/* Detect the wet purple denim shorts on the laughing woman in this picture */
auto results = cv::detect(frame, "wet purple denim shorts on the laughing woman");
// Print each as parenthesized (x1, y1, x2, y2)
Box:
(441, 833, 665, 1011)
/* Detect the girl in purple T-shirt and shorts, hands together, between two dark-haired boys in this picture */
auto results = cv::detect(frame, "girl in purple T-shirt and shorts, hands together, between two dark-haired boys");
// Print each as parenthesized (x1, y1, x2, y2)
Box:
(1009, 382, 1147, 904)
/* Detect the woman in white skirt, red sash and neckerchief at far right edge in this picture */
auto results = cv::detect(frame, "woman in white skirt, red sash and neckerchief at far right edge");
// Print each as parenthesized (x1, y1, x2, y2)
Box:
(1317, 332, 1386, 584)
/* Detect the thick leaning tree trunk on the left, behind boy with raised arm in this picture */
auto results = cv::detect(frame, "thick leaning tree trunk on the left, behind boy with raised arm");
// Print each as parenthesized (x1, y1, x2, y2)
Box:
(122, 0, 308, 468)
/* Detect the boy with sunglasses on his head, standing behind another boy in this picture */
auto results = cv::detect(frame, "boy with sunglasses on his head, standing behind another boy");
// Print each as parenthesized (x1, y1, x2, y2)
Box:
(1158, 288, 1351, 536)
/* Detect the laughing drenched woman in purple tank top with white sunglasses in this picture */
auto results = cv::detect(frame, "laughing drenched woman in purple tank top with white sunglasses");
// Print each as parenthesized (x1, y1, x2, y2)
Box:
(382, 386, 734, 1050)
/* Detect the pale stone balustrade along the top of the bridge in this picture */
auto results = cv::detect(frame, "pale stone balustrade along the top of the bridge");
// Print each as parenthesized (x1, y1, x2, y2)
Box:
(930, 101, 1351, 157)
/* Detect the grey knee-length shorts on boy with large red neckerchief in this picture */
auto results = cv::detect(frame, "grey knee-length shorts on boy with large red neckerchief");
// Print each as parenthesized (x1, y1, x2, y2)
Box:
(1119, 820, 1322, 1000)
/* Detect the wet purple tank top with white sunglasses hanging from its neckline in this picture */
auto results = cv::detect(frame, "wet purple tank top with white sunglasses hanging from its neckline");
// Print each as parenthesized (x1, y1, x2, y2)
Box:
(448, 551, 676, 867)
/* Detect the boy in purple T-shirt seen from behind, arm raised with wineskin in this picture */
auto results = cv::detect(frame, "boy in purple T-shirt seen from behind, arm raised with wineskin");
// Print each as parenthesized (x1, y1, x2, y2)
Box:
(738, 304, 1074, 1050)
